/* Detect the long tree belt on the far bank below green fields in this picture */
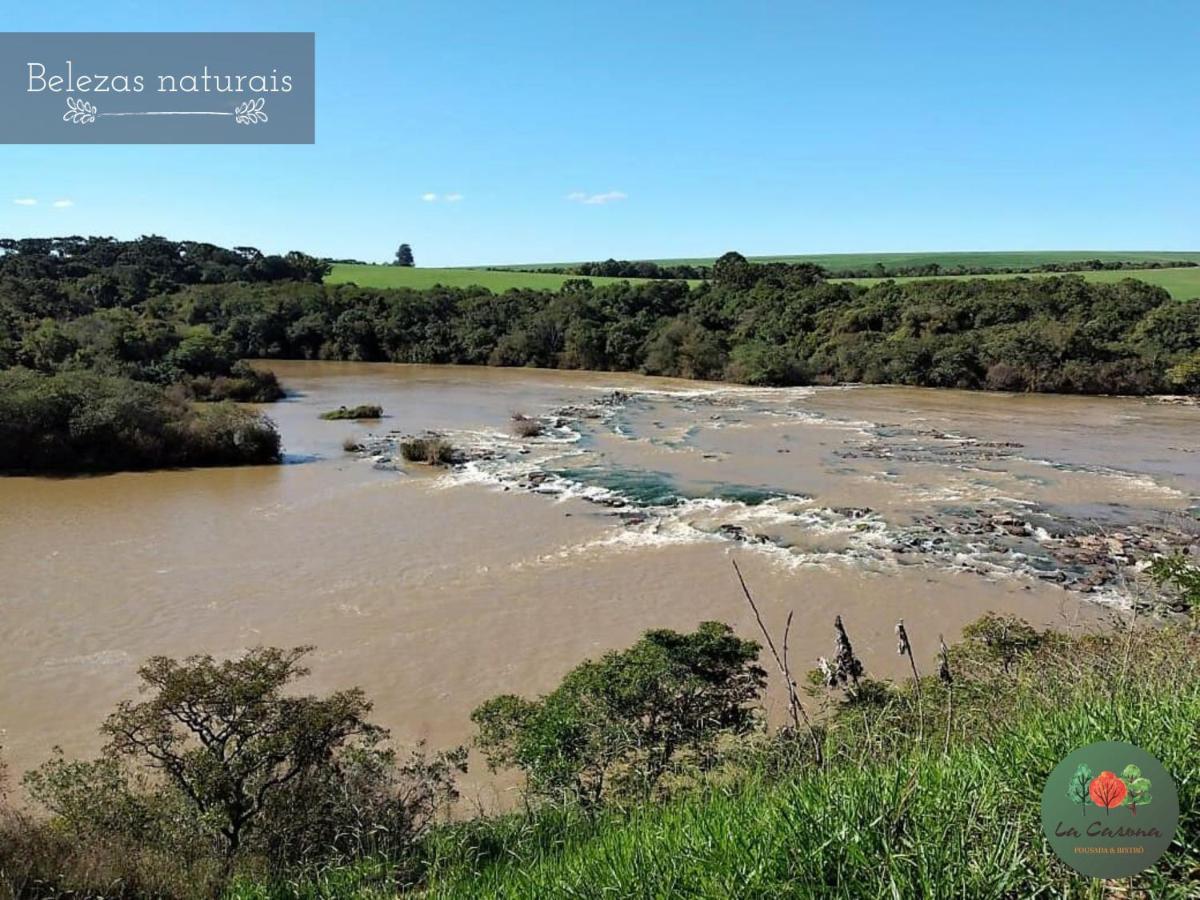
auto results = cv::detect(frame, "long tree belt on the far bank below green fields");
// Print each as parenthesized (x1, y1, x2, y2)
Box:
(166, 254, 1200, 394)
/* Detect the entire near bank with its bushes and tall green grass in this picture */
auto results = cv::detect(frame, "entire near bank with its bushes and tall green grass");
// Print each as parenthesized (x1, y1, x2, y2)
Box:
(0, 580, 1200, 900)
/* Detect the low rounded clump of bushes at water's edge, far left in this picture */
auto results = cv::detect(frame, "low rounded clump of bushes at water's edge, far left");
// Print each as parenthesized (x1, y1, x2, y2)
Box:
(0, 368, 280, 472)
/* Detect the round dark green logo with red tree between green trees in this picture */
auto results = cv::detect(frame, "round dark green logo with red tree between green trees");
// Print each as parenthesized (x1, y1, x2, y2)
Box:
(1042, 740, 1180, 878)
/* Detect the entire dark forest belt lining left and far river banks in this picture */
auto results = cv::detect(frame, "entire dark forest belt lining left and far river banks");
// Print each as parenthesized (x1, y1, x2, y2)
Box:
(0, 238, 1200, 469)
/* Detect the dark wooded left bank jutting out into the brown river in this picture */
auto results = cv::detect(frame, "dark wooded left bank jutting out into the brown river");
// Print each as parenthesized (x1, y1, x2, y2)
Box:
(0, 238, 328, 470)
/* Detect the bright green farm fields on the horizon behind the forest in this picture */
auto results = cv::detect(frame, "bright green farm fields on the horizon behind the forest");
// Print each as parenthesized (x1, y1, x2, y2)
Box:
(325, 259, 1200, 300)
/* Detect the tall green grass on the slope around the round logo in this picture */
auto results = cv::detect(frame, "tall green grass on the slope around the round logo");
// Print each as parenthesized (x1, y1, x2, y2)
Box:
(232, 626, 1200, 899)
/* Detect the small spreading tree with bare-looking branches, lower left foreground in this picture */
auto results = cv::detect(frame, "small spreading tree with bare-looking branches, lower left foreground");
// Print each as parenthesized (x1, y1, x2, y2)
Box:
(103, 647, 383, 859)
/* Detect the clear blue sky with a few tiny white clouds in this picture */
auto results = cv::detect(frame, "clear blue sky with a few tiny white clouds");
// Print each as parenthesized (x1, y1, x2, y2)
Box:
(0, 0, 1200, 265)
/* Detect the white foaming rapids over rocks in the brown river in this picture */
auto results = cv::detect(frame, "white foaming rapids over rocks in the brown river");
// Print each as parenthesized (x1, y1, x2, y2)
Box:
(359, 388, 1200, 607)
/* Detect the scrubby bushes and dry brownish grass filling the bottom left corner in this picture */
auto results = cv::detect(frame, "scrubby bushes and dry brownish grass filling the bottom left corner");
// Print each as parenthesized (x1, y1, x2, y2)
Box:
(0, 648, 467, 898)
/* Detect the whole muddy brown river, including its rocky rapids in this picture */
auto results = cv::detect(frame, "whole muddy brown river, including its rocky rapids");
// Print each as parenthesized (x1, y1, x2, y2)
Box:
(0, 362, 1200, 805)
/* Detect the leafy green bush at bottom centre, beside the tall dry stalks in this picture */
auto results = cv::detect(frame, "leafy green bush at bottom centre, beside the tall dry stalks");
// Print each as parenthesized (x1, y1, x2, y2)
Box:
(472, 622, 766, 805)
